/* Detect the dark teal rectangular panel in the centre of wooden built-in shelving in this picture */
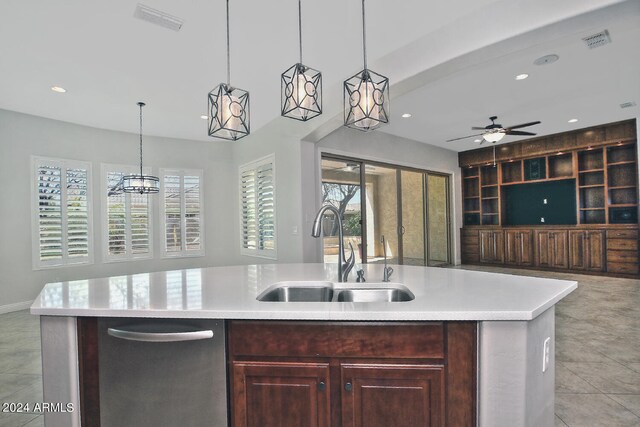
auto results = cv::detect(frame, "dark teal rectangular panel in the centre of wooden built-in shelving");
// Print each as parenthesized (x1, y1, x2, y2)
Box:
(502, 179, 577, 225)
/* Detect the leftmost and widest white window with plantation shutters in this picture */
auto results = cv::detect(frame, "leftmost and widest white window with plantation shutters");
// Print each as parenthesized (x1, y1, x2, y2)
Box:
(31, 157, 93, 269)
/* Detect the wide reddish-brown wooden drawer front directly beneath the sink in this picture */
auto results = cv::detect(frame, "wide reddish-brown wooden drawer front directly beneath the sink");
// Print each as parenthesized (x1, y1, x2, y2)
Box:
(229, 321, 444, 359)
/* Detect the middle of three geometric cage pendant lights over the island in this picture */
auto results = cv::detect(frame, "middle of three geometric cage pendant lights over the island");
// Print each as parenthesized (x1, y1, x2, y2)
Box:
(280, 0, 322, 122)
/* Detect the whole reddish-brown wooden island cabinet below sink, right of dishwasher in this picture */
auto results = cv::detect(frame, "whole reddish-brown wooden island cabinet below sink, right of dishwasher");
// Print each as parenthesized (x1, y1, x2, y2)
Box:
(228, 321, 477, 427)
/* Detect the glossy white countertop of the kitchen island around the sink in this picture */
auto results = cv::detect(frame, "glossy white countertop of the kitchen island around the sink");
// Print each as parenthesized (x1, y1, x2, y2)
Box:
(31, 264, 577, 321)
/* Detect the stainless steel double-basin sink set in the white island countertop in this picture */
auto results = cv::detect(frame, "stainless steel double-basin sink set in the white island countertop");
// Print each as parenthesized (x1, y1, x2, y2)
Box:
(256, 281, 415, 302)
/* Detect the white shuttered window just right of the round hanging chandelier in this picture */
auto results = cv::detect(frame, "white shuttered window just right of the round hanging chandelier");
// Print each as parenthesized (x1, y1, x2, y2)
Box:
(160, 169, 204, 257)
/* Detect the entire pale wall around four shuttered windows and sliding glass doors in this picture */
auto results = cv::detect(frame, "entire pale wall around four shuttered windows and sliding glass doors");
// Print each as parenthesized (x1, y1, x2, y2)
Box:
(0, 110, 461, 312)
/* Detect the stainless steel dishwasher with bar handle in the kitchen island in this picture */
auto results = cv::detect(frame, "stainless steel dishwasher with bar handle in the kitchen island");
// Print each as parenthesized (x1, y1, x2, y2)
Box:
(98, 318, 227, 427)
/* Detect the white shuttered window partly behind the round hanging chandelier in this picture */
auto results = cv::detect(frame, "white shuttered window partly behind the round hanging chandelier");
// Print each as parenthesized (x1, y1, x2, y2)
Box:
(101, 164, 156, 261)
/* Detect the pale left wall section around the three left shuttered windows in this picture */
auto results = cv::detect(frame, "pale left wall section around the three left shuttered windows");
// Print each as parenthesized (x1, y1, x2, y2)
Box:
(0, 110, 237, 313)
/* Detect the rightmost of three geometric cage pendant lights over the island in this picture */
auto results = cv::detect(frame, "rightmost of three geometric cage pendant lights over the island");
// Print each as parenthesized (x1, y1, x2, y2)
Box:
(344, 0, 389, 131)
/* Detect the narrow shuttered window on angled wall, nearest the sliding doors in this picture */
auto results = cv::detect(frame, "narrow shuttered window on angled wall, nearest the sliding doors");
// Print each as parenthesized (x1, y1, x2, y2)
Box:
(240, 154, 277, 259)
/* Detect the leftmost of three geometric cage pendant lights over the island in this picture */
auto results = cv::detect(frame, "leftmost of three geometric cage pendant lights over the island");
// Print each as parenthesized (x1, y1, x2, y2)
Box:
(209, 0, 249, 141)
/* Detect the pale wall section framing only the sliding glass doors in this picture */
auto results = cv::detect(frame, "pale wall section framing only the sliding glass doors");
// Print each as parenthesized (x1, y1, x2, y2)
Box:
(301, 126, 462, 264)
